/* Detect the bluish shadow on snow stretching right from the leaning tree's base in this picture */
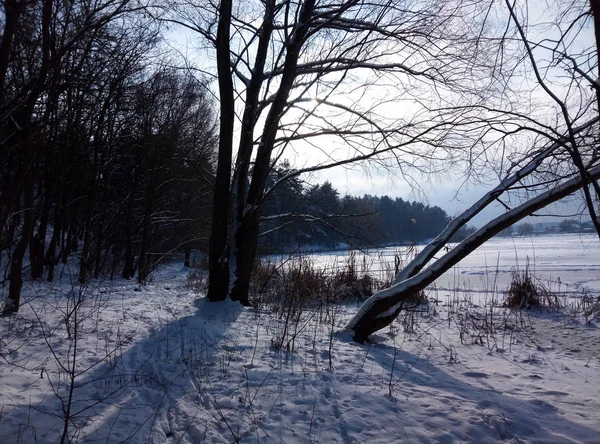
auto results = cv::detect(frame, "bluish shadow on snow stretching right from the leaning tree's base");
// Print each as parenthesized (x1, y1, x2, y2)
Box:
(367, 344, 600, 443)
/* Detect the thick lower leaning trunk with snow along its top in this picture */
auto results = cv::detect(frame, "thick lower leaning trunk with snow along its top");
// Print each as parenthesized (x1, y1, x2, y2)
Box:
(348, 166, 600, 342)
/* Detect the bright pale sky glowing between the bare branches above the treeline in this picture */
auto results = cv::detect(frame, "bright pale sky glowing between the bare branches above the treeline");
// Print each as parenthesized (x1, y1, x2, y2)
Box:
(162, 2, 594, 225)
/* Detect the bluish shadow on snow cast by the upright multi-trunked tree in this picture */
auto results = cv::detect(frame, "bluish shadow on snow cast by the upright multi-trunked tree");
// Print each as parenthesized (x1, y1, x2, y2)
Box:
(0, 298, 244, 443)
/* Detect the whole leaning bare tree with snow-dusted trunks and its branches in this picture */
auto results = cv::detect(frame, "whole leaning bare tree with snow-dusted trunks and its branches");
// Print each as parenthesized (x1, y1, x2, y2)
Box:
(348, 1, 600, 341)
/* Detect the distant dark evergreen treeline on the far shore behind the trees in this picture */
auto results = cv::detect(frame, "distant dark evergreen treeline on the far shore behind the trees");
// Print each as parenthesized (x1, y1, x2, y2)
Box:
(260, 164, 472, 253)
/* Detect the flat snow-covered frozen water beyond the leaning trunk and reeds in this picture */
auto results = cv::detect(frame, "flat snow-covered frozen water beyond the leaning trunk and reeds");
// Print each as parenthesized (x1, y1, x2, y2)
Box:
(311, 234, 600, 294)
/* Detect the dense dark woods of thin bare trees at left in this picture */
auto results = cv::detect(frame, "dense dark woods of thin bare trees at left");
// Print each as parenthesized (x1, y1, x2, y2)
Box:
(0, 0, 216, 313)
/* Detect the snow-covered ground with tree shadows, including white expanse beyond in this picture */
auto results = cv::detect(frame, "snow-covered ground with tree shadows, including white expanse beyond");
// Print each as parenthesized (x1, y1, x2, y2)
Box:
(0, 236, 600, 443)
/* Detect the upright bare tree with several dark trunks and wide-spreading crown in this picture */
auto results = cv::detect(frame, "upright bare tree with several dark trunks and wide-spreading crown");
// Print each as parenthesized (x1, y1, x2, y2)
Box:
(168, 0, 504, 304)
